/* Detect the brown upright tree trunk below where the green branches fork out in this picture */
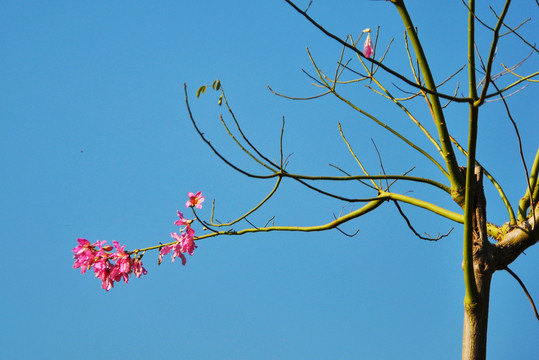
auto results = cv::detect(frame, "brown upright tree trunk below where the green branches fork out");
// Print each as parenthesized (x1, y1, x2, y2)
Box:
(462, 167, 495, 360)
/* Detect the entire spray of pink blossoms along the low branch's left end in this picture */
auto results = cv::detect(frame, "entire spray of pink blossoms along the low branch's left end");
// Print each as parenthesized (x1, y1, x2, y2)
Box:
(73, 191, 205, 291)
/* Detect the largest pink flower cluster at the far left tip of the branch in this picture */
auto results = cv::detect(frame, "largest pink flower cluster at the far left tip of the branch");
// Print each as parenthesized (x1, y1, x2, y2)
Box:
(73, 238, 148, 291)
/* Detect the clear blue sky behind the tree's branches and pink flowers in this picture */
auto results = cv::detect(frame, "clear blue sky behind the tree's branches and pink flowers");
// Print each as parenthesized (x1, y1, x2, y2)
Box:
(0, 0, 539, 359)
